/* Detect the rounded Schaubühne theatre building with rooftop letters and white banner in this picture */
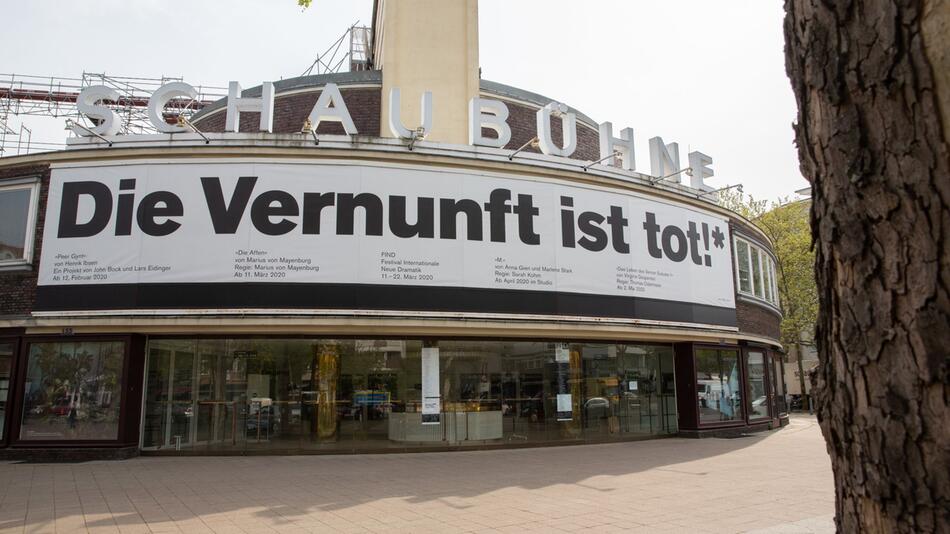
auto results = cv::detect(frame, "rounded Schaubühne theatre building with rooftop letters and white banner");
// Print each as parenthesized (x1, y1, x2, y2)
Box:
(0, 0, 787, 458)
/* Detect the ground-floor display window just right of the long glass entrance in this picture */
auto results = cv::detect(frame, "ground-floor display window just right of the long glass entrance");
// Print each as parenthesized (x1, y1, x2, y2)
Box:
(695, 349, 742, 424)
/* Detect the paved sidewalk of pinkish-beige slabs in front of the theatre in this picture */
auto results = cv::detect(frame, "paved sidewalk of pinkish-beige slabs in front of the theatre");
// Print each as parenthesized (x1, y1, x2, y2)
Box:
(0, 416, 834, 533)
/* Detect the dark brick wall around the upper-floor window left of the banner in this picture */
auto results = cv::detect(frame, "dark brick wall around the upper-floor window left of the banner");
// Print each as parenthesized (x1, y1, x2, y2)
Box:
(0, 165, 49, 316)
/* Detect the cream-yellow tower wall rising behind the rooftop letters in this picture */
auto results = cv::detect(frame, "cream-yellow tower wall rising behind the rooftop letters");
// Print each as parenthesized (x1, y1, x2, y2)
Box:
(374, 0, 478, 144)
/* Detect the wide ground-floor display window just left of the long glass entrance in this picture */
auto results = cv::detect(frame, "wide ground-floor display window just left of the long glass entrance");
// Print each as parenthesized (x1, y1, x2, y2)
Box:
(20, 341, 125, 440)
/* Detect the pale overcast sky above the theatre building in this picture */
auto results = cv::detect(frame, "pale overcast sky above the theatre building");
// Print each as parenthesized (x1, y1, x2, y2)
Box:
(0, 0, 808, 200)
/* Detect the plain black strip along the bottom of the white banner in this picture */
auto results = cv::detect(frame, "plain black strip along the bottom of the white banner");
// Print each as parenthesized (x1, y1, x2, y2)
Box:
(35, 282, 736, 326)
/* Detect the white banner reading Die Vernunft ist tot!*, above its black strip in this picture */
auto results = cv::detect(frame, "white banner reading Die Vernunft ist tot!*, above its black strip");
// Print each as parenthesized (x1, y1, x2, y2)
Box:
(39, 161, 735, 308)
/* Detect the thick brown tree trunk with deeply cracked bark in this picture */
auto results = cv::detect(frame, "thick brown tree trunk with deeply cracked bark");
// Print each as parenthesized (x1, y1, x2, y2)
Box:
(785, 0, 950, 532)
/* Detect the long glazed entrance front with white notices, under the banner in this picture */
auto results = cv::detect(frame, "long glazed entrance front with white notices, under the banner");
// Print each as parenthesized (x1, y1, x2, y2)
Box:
(143, 338, 676, 450)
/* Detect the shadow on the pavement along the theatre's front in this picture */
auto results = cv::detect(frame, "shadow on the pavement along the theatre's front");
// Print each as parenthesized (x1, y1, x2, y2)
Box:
(0, 429, 787, 529)
